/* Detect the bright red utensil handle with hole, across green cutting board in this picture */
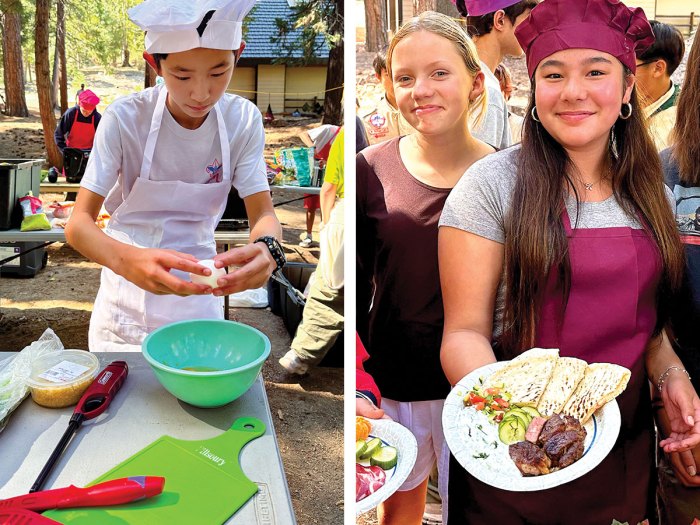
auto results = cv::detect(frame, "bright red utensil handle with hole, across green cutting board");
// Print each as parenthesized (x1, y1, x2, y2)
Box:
(0, 476, 165, 512)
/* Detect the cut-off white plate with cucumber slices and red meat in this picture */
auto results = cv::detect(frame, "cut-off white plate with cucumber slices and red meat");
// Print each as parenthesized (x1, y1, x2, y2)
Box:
(355, 419, 418, 516)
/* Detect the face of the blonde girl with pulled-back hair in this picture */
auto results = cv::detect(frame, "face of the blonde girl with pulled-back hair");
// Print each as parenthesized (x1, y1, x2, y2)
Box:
(391, 30, 483, 135)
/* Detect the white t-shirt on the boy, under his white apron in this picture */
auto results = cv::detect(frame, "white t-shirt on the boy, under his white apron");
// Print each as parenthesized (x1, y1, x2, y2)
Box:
(81, 86, 270, 214)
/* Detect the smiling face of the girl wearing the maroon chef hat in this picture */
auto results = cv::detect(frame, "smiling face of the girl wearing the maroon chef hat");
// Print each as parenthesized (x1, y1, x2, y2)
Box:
(535, 49, 639, 155)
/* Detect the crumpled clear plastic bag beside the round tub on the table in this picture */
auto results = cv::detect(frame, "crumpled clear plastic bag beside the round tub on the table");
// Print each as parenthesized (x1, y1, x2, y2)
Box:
(0, 328, 63, 432)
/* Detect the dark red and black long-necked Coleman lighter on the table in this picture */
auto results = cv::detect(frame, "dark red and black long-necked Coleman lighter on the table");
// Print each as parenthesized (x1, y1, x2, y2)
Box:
(29, 361, 129, 493)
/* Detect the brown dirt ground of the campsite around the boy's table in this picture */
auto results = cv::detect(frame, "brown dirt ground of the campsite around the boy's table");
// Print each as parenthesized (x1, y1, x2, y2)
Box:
(0, 70, 343, 525)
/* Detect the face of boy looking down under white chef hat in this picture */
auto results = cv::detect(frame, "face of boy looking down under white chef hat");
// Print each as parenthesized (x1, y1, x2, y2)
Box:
(158, 47, 236, 129)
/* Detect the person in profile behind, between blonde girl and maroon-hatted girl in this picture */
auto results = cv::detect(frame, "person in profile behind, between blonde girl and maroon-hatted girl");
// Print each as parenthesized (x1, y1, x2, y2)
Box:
(453, 0, 537, 149)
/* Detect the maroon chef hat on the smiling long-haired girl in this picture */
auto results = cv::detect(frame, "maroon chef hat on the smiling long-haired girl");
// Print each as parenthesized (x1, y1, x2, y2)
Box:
(515, 0, 654, 78)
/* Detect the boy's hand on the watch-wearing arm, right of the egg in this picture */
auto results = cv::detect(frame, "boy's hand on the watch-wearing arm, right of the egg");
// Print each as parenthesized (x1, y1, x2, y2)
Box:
(214, 242, 277, 296)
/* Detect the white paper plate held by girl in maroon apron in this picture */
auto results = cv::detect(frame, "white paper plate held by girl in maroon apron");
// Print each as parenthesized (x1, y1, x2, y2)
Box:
(442, 361, 620, 492)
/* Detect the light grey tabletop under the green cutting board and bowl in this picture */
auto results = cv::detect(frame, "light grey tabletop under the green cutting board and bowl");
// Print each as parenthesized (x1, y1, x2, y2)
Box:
(0, 352, 296, 525)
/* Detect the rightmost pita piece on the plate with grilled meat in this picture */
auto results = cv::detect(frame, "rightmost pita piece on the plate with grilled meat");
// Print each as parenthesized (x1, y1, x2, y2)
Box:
(561, 363, 631, 425)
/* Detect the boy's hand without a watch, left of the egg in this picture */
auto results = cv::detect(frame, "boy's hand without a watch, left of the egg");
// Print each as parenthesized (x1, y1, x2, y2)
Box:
(114, 245, 212, 296)
